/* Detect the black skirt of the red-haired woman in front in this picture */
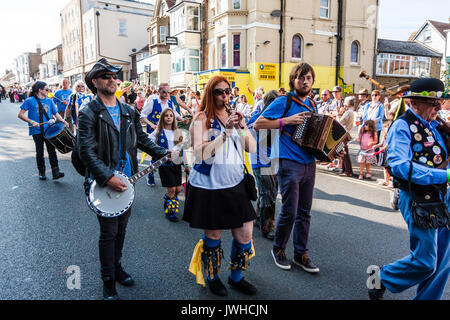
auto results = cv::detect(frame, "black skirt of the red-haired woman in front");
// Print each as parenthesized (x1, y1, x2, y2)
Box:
(183, 181, 256, 230)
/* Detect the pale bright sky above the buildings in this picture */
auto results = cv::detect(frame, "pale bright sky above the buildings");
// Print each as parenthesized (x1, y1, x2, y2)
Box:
(0, 0, 450, 76)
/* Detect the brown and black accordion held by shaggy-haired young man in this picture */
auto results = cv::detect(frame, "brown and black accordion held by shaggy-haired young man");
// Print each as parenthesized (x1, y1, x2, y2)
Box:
(291, 113, 351, 162)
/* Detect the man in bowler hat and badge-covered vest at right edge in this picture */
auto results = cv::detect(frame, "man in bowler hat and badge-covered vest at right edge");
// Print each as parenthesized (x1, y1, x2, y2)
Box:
(369, 78, 450, 300)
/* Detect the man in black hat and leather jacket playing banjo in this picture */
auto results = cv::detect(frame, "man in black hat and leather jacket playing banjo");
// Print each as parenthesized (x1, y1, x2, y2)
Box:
(78, 58, 170, 300)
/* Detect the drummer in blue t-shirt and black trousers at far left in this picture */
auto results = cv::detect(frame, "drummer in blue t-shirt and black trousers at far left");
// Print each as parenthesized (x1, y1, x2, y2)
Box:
(18, 81, 68, 180)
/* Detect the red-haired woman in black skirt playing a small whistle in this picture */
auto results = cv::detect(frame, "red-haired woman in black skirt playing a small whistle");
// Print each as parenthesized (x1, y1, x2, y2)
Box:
(183, 76, 256, 296)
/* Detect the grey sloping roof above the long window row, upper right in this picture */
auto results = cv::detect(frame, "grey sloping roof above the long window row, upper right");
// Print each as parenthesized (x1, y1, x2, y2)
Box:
(377, 39, 442, 58)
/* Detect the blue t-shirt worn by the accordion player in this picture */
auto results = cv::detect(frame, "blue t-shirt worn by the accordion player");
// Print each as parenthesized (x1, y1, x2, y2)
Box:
(261, 92, 315, 164)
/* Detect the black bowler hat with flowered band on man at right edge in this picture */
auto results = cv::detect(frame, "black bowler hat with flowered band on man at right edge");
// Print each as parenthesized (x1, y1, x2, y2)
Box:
(403, 78, 449, 99)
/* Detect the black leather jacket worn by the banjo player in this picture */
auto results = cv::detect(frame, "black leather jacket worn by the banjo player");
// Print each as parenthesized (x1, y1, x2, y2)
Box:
(78, 96, 167, 186)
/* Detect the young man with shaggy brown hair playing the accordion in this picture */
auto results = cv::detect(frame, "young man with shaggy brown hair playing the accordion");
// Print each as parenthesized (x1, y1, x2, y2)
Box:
(254, 63, 319, 273)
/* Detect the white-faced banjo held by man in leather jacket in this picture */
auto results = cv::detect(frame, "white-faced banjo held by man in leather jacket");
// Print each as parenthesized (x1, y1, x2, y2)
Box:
(86, 142, 188, 218)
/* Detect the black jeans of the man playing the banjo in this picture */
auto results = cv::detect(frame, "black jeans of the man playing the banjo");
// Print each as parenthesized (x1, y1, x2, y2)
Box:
(97, 208, 131, 280)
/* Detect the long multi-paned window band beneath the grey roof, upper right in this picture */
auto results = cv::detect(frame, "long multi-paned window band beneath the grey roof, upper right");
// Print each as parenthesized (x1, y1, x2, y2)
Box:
(377, 53, 431, 77)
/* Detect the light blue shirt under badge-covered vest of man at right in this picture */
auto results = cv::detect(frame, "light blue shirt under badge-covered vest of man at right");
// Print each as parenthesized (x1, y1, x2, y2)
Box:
(386, 109, 447, 185)
